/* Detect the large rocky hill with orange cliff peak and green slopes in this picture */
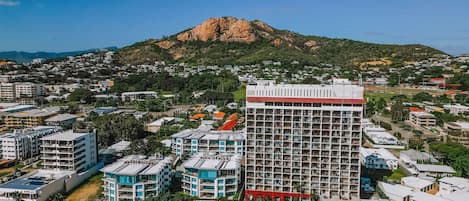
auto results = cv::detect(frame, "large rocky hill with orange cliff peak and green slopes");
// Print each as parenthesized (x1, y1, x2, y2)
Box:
(118, 17, 444, 67)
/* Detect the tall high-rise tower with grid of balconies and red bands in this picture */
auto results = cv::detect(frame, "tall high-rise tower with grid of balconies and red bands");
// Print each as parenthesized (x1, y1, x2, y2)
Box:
(245, 80, 364, 201)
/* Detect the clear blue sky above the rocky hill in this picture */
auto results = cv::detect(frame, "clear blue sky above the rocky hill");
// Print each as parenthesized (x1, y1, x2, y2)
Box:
(0, 0, 469, 54)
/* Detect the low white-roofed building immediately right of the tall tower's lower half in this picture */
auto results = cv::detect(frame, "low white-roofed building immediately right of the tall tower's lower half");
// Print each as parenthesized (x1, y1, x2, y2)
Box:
(360, 147, 398, 171)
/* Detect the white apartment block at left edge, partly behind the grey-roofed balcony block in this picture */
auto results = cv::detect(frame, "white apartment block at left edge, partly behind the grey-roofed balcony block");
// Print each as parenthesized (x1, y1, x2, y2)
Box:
(0, 126, 62, 161)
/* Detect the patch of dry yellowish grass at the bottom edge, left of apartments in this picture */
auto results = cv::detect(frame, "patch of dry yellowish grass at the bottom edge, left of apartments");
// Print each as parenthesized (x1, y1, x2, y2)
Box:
(65, 174, 103, 201)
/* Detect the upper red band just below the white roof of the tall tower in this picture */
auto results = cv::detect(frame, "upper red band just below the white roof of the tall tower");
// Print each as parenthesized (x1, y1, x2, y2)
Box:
(246, 97, 365, 104)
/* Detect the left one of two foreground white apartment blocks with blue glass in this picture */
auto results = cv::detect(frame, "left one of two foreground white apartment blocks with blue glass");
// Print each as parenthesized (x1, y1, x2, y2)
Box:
(101, 155, 172, 201)
